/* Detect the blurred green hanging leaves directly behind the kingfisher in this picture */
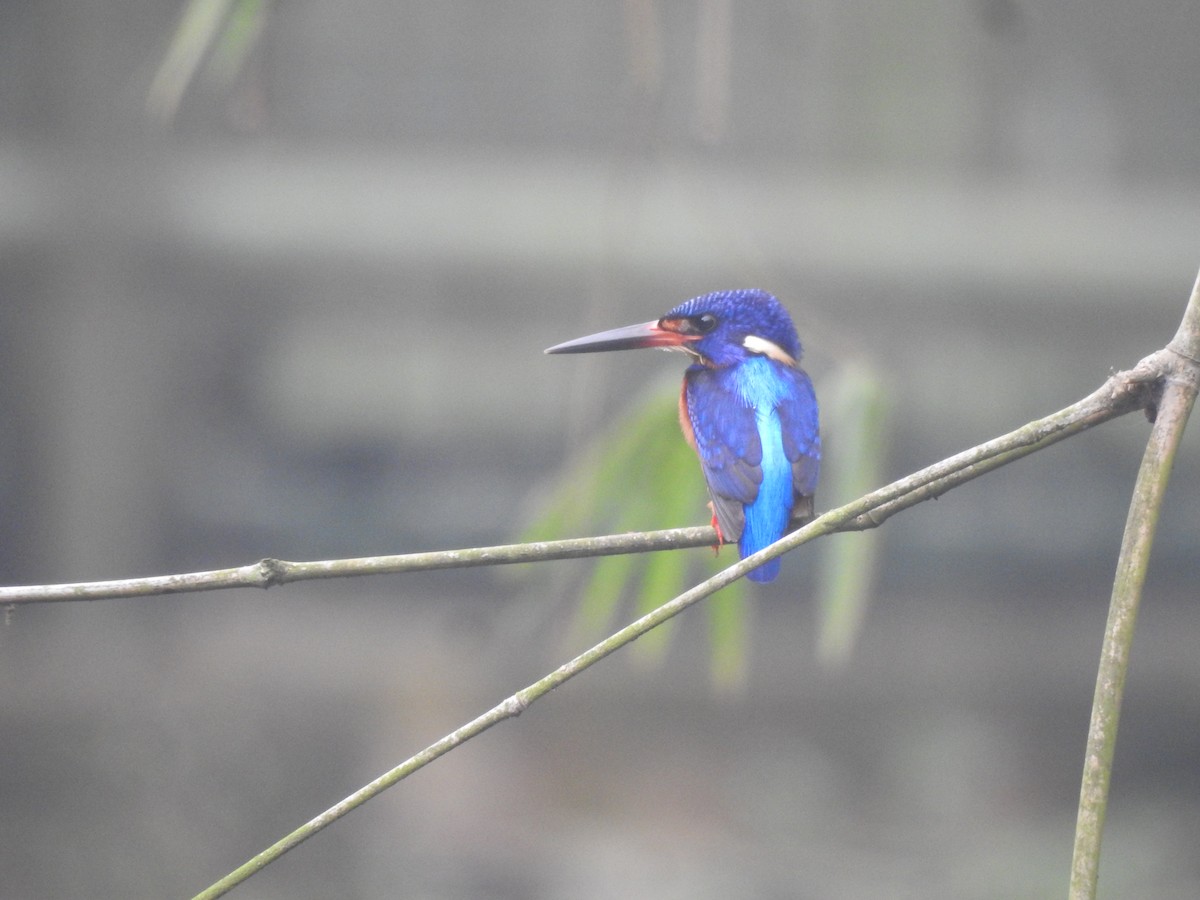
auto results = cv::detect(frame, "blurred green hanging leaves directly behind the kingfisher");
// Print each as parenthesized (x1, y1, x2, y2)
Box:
(522, 365, 886, 690)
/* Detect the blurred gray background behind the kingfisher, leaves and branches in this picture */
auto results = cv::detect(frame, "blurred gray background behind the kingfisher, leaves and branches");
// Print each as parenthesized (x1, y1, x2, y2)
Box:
(0, 0, 1200, 899)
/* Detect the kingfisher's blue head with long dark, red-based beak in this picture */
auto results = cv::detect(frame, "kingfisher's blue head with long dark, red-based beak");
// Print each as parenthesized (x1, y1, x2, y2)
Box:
(546, 289, 800, 367)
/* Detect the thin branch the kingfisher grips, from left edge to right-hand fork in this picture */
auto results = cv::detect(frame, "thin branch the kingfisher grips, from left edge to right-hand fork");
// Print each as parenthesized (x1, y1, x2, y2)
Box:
(0, 350, 1161, 605)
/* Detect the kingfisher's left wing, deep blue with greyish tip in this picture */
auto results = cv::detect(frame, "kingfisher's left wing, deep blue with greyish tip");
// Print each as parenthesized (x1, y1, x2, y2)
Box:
(684, 367, 762, 542)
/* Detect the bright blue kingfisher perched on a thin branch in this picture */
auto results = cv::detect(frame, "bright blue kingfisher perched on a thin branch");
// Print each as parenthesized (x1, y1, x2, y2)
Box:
(546, 288, 821, 582)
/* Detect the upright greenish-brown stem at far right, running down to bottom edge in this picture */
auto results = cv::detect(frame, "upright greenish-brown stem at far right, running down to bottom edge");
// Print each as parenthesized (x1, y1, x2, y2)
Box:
(1069, 270, 1200, 900)
